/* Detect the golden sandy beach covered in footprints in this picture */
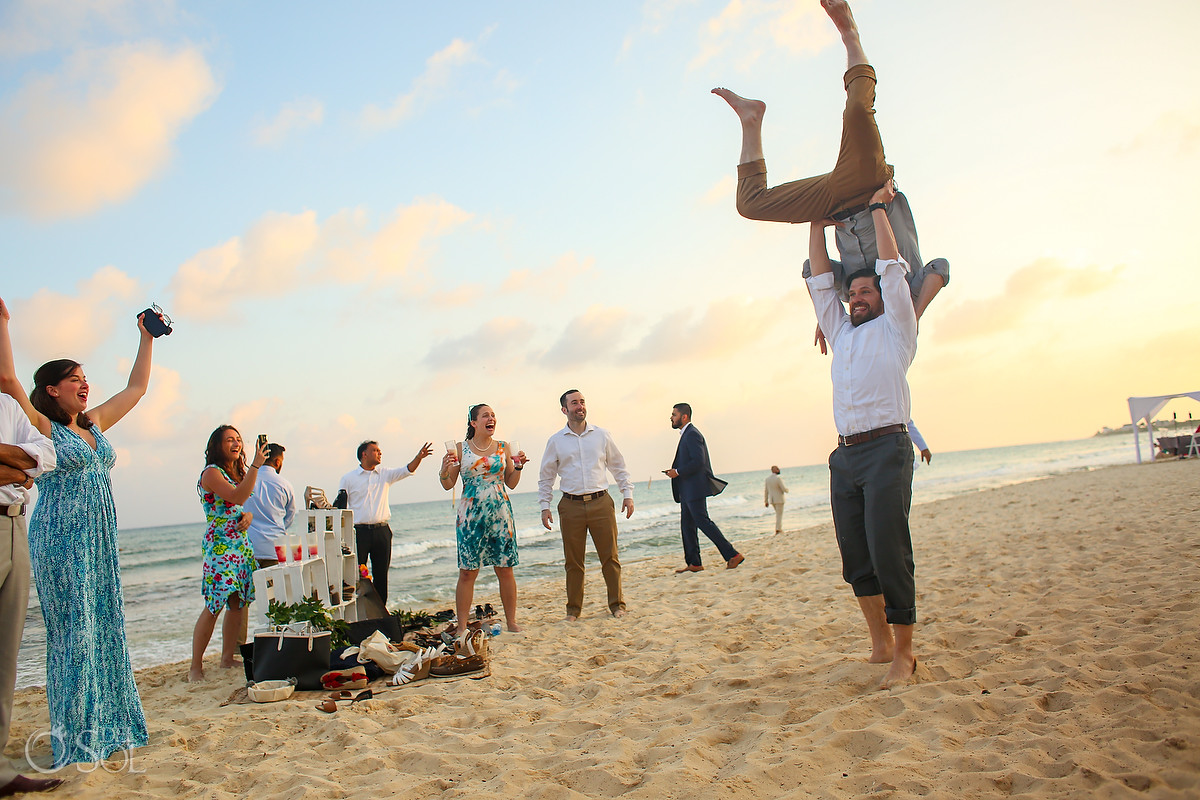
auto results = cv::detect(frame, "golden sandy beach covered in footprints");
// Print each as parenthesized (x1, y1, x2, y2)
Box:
(5, 461, 1200, 800)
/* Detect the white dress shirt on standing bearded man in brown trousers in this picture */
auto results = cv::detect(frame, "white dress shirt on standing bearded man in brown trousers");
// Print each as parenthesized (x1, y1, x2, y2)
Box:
(538, 423, 634, 511)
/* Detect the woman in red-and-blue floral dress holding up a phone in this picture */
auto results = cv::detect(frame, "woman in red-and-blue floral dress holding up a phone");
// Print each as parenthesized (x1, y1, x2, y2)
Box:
(187, 425, 266, 682)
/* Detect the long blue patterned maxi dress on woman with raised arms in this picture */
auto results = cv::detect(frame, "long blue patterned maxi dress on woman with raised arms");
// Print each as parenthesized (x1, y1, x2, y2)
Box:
(29, 422, 146, 766)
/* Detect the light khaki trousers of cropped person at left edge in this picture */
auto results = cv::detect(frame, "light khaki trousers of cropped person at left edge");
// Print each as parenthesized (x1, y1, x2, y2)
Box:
(0, 516, 29, 786)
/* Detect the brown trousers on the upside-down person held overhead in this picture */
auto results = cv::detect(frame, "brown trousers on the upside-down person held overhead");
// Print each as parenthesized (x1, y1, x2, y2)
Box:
(738, 64, 892, 222)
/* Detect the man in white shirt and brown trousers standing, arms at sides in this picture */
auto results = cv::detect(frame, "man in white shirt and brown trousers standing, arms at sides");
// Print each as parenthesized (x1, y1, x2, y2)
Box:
(538, 389, 634, 622)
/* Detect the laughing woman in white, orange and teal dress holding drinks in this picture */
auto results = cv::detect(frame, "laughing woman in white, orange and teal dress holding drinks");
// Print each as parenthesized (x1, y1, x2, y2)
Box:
(438, 404, 528, 638)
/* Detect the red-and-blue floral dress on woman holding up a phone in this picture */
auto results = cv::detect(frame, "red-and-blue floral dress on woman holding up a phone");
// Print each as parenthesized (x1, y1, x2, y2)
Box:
(196, 464, 256, 616)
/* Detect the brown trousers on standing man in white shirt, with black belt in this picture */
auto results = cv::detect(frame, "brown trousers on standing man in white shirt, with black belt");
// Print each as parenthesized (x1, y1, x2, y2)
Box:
(558, 492, 625, 616)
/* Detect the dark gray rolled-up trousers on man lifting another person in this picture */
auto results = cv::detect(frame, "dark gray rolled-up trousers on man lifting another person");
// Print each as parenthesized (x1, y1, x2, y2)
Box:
(829, 433, 917, 625)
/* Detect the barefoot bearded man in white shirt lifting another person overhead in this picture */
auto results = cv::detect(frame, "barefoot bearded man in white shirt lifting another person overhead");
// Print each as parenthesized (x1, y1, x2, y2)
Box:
(808, 181, 917, 687)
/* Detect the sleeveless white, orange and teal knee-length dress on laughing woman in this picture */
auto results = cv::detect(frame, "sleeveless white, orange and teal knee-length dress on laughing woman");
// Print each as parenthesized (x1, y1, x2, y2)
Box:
(455, 440, 517, 570)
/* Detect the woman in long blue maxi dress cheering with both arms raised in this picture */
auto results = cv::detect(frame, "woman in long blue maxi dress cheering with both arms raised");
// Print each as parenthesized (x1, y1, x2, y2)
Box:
(0, 301, 154, 768)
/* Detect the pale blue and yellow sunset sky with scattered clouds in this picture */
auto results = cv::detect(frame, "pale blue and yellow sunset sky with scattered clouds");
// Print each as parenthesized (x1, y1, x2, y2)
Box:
(0, 0, 1200, 527)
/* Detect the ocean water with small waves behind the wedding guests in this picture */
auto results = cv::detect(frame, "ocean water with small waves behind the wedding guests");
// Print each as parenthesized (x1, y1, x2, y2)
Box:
(17, 434, 1148, 687)
